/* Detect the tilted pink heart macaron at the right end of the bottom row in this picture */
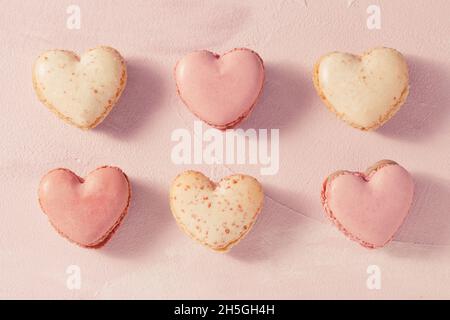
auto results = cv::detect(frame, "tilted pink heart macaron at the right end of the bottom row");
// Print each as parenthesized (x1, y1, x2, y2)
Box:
(321, 160, 414, 248)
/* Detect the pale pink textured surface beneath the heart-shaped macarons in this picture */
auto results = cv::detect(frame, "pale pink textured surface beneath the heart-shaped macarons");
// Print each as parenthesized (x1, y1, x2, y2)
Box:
(0, 0, 450, 298)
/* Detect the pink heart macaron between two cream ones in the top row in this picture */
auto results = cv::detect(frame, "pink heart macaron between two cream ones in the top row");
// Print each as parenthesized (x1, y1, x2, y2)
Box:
(175, 48, 264, 130)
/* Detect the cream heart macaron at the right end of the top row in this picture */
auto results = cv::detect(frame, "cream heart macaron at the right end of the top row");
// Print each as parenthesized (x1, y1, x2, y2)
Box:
(313, 48, 409, 130)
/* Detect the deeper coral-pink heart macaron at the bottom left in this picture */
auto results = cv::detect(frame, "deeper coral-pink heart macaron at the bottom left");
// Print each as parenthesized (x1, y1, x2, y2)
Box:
(39, 166, 131, 248)
